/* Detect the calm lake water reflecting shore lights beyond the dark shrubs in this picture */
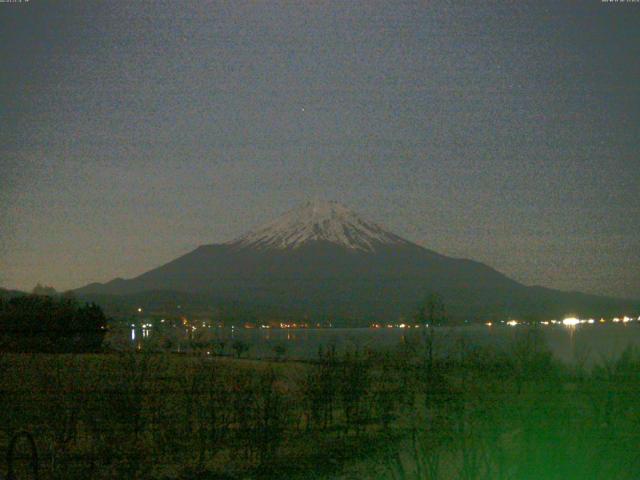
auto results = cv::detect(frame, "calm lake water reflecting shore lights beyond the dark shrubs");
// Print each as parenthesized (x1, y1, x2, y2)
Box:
(131, 323, 640, 363)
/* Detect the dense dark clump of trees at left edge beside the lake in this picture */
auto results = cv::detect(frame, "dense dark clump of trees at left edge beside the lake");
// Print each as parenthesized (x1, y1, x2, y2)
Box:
(0, 295, 107, 353)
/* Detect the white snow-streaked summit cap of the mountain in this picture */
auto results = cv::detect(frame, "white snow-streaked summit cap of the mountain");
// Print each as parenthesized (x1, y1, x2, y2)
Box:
(230, 201, 409, 252)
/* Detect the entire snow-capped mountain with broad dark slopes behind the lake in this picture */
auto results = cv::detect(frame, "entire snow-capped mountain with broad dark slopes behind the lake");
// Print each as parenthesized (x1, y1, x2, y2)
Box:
(76, 202, 638, 325)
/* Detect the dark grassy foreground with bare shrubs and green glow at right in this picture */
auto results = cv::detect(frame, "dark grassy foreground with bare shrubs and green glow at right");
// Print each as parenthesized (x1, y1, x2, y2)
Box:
(0, 331, 640, 480)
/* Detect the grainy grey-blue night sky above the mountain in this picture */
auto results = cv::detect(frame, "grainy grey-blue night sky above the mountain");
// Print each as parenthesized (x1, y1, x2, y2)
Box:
(0, 0, 640, 298)
